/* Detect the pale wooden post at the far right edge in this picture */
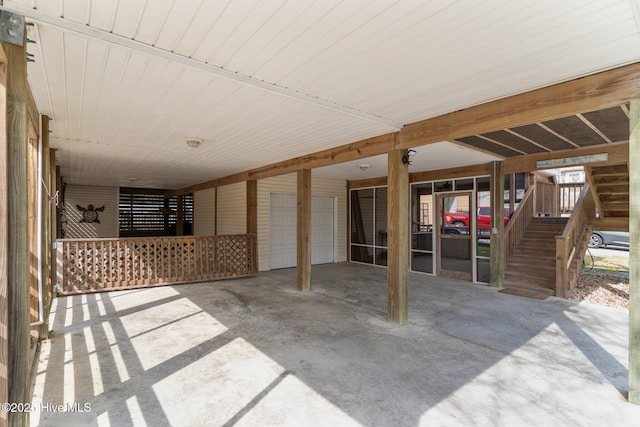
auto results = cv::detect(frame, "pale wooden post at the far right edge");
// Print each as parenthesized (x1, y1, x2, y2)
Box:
(628, 99, 640, 405)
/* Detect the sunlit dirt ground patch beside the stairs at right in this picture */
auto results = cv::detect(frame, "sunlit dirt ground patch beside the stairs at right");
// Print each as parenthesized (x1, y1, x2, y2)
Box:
(567, 269, 629, 309)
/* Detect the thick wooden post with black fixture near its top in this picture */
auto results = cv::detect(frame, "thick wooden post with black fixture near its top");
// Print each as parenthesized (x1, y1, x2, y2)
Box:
(387, 149, 409, 324)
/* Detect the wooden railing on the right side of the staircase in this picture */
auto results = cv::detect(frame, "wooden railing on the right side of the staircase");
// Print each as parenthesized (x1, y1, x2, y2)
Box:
(556, 184, 596, 298)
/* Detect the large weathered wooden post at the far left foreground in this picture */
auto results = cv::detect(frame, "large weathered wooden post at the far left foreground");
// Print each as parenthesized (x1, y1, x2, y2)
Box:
(2, 35, 30, 426)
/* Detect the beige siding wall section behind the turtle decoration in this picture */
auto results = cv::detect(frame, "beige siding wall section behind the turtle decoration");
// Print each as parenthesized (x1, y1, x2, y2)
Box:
(63, 185, 118, 239)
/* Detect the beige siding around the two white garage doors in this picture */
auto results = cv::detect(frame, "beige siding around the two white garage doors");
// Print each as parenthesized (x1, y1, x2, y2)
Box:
(258, 173, 347, 271)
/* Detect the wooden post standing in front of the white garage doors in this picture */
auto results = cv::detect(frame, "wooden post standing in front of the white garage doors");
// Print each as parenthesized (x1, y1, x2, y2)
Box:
(296, 169, 311, 291)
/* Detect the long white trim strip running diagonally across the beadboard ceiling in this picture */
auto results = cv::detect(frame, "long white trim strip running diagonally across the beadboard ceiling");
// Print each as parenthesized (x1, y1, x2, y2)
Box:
(0, 5, 404, 131)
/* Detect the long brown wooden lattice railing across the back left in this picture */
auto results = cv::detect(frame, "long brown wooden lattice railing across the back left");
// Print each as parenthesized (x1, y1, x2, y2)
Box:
(56, 234, 257, 294)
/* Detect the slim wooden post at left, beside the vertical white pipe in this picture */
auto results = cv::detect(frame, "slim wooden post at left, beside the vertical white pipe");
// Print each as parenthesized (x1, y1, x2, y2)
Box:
(38, 116, 50, 340)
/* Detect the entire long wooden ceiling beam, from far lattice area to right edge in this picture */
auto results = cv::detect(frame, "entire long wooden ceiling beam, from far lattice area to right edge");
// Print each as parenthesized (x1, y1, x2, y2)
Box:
(175, 62, 640, 194)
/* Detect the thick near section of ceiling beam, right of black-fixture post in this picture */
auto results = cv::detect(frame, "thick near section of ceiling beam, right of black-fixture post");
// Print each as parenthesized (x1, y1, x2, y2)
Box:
(398, 62, 640, 148)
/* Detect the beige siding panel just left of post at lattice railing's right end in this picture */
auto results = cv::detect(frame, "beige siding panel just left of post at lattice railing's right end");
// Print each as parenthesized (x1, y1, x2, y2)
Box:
(216, 182, 247, 234)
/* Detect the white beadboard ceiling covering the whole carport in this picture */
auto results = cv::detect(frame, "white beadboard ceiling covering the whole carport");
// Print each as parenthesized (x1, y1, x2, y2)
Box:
(3, 0, 640, 189)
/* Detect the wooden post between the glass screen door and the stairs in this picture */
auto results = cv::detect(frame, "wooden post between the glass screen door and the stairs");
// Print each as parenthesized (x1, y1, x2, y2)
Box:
(490, 161, 506, 288)
